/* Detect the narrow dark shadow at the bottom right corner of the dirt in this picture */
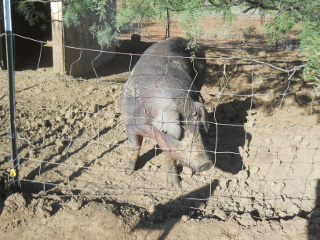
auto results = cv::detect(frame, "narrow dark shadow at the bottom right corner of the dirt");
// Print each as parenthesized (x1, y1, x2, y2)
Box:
(308, 180, 320, 240)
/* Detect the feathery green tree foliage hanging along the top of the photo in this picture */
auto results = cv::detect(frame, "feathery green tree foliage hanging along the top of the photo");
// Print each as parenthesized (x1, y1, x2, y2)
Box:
(6, 0, 320, 88)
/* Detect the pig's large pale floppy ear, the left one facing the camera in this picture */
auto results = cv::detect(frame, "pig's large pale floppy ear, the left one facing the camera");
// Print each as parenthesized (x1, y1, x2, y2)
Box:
(152, 109, 182, 140)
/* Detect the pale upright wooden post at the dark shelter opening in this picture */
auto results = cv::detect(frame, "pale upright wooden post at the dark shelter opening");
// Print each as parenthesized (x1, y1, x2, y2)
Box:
(50, 2, 66, 74)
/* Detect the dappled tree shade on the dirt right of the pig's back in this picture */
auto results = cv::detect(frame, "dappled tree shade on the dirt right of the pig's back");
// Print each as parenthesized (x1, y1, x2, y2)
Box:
(204, 45, 320, 122)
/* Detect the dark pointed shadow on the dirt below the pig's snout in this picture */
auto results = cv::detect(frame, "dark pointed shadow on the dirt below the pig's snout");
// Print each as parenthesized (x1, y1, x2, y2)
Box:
(132, 180, 219, 240)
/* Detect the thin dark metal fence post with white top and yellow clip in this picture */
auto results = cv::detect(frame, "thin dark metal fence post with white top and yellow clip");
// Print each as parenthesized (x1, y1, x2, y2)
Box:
(3, 0, 20, 190)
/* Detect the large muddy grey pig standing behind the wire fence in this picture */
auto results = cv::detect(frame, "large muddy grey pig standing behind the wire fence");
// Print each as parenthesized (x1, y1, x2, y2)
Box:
(119, 37, 213, 188)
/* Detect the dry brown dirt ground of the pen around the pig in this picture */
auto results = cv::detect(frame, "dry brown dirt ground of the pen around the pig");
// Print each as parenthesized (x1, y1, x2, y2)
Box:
(0, 13, 320, 240)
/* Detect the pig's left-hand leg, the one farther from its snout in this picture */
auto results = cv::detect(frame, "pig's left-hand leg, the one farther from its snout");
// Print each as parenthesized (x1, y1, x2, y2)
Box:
(123, 128, 143, 175)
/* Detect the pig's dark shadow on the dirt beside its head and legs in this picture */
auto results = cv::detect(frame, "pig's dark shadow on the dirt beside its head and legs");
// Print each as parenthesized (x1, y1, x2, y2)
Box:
(136, 98, 253, 174)
